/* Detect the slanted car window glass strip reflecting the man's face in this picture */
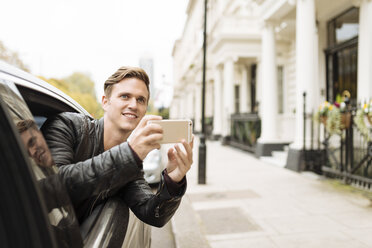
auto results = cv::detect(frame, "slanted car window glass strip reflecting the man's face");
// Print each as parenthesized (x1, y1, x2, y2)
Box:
(0, 78, 82, 247)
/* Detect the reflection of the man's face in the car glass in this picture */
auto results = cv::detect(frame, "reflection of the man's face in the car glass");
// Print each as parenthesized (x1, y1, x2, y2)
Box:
(21, 128, 53, 166)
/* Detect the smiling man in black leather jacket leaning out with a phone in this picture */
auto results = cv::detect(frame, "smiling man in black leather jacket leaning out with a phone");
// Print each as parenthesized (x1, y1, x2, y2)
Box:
(42, 67, 192, 227)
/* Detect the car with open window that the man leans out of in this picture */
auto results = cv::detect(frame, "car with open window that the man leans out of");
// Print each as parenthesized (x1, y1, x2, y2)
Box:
(0, 61, 151, 247)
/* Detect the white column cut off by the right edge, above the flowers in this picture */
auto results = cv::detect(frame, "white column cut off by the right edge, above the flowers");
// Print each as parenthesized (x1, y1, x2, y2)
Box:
(357, 0, 372, 102)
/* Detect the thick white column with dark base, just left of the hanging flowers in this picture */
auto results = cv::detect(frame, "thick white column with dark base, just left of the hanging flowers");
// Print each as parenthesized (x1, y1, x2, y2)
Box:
(286, 0, 319, 171)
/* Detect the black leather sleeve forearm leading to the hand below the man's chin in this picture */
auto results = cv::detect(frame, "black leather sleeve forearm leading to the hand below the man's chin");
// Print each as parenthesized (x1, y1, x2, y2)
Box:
(59, 143, 141, 208)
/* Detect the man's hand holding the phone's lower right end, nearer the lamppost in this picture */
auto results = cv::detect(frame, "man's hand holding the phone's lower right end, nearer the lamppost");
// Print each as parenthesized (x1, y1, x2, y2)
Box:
(166, 136, 194, 183)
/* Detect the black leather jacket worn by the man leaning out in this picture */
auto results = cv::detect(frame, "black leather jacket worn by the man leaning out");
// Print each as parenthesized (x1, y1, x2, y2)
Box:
(41, 113, 186, 227)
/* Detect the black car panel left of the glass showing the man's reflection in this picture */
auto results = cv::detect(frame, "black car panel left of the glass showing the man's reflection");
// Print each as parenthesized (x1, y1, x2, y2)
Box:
(0, 94, 57, 247)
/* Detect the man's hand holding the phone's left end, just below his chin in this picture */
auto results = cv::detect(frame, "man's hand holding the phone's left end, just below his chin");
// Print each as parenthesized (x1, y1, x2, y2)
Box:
(128, 115, 163, 160)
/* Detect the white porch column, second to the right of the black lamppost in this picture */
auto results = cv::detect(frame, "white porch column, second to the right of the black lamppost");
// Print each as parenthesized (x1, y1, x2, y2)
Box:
(222, 58, 234, 137)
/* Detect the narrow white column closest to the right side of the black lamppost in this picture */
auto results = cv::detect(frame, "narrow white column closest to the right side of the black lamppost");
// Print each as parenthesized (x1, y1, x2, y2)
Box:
(213, 66, 223, 137)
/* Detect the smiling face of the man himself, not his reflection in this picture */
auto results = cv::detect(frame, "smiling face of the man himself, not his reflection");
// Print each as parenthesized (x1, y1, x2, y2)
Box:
(102, 78, 149, 133)
